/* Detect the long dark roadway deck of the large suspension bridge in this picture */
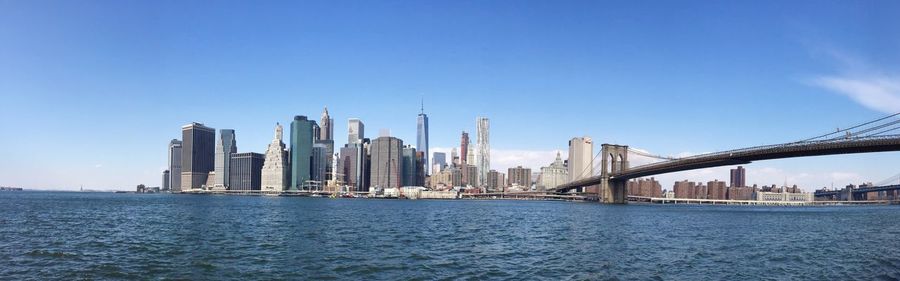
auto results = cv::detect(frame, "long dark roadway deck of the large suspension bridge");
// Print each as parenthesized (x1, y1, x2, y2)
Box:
(556, 135, 900, 192)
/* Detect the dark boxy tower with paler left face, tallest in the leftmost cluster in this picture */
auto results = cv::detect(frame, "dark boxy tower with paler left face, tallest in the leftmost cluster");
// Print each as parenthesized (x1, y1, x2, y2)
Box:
(181, 122, 216, 191)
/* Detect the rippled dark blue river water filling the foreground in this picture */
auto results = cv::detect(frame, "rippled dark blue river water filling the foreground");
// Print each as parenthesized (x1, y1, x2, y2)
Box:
(0, 192, 900, 280)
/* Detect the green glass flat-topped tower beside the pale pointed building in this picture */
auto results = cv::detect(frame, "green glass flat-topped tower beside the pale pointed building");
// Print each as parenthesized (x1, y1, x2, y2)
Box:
(288, 115, 315, 190)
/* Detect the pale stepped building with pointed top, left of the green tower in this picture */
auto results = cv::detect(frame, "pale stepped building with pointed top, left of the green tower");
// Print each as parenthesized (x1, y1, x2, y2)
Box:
(261, 123, 291, 192)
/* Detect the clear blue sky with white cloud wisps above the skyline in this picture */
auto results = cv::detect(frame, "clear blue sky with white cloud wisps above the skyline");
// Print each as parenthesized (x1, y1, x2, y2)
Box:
(0, 0, 900, 191)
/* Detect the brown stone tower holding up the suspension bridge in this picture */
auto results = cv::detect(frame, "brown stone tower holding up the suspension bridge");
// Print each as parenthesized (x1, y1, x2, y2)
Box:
(597, 143, 628, 204)
